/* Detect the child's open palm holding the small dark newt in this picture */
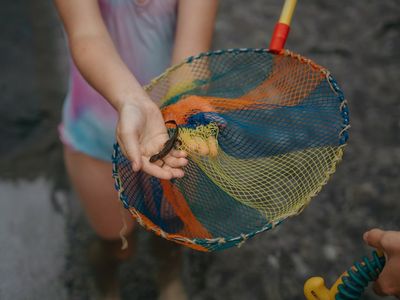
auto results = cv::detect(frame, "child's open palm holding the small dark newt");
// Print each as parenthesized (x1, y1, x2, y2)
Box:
(116, 101, 188, 179)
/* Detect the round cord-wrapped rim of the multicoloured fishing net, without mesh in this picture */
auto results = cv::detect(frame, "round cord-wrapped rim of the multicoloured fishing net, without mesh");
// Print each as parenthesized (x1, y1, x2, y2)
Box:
(112, 48, 350, 252)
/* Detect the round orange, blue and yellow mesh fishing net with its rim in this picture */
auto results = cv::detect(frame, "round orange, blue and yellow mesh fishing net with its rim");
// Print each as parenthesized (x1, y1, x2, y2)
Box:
(113, 48, 349, 251)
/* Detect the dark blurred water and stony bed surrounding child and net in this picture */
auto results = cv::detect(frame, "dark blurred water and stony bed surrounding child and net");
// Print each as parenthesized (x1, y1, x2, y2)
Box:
(0, 0, 400, 300)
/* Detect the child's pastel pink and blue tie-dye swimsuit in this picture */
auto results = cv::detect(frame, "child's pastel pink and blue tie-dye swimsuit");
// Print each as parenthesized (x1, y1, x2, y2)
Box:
(60, 0, 178, 161)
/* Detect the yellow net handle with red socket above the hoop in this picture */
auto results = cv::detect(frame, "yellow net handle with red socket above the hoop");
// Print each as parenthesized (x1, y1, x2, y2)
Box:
(269, 0, 297, 53)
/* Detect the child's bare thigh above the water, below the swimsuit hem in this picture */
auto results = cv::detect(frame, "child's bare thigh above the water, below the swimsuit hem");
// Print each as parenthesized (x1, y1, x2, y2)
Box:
(64, 147, 134, 240)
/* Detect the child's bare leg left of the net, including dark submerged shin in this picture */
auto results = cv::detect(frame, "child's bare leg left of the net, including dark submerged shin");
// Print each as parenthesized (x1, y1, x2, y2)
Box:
(64, 147, 135, 300)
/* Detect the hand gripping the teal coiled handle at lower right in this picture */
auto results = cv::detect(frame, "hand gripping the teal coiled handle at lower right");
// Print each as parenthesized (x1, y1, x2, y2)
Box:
(364, 229, 400, 299)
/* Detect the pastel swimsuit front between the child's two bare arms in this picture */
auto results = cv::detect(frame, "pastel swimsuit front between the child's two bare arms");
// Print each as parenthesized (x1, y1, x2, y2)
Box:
(99, 0, 177, 84)
